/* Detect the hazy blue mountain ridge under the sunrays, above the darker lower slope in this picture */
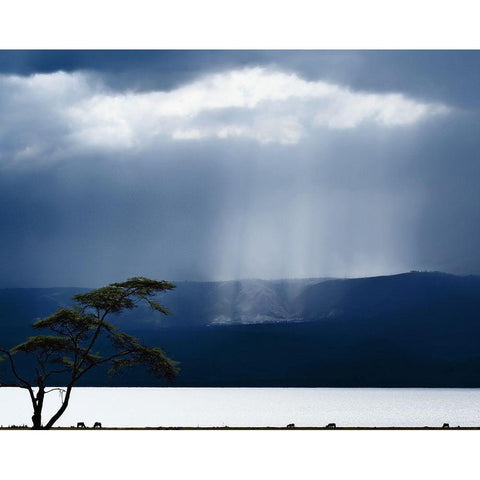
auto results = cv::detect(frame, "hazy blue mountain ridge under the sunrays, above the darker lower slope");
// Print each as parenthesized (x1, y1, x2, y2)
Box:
(0, 271, 480, 329)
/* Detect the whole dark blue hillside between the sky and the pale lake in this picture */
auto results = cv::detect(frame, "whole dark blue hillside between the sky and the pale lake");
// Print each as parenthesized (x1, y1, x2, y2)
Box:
(0, 272, 480, 387)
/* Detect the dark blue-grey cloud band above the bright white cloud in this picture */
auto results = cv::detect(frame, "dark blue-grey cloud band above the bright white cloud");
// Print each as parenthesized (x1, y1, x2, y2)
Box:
(0, 50, 480, 107)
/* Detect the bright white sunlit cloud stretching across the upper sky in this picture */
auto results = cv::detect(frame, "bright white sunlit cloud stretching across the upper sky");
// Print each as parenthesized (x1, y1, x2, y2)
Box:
(0, 68, 449, 158)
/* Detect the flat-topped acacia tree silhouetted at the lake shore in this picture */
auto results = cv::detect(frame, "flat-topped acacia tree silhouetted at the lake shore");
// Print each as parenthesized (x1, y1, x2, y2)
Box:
(0, 277, 178, 429)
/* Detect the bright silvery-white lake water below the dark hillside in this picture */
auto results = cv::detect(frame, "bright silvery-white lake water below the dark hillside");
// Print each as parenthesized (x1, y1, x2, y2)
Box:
(0, 387, 480, 427)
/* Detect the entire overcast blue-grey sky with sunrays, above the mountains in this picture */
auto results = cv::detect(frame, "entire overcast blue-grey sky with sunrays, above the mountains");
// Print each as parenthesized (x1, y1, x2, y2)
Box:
(0, 51, 480, 287)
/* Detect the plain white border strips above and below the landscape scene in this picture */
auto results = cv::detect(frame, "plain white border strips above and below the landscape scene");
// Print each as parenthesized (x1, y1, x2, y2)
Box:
(0, 0, 480, 480)
